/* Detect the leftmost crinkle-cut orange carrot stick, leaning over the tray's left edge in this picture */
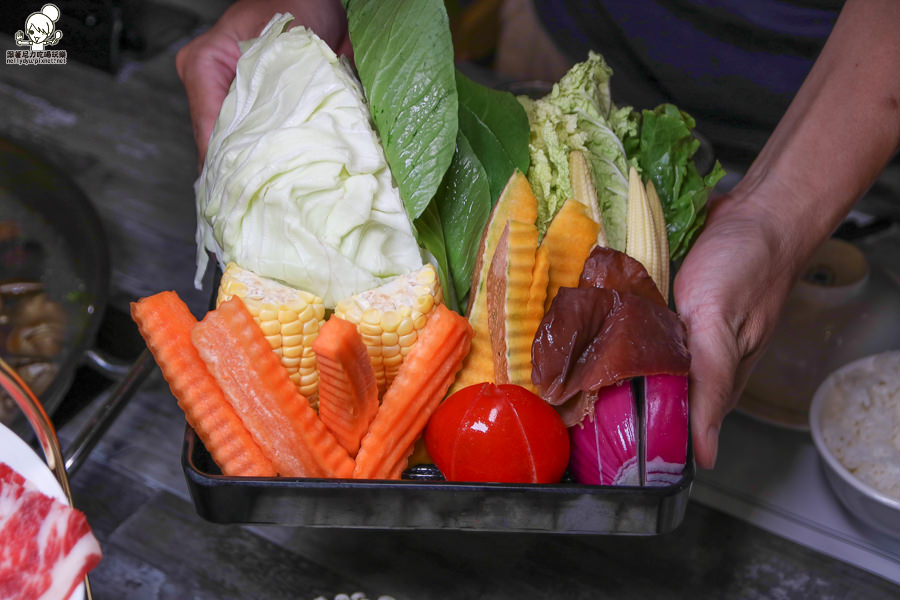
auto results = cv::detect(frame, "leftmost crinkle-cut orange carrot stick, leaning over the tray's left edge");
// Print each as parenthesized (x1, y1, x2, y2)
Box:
(131, 291, 277, 477)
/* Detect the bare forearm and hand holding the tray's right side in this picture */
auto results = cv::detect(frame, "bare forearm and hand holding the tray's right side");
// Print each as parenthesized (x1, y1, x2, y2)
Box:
(674, 0, 900, 468)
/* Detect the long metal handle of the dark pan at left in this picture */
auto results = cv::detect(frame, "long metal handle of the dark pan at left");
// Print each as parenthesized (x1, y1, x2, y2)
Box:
(65, 349, 156, 475)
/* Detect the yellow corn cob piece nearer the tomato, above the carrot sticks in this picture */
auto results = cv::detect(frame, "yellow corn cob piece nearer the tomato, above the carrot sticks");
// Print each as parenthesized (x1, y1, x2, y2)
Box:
(334, 264, 443, 394)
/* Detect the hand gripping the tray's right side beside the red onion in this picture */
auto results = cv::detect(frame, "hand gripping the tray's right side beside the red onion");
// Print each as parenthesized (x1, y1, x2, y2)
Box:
(674, 190, 802, 469)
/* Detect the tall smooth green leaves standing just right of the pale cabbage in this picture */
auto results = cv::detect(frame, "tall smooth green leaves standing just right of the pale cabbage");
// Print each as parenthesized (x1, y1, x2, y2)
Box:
(344, 0, 529, 308)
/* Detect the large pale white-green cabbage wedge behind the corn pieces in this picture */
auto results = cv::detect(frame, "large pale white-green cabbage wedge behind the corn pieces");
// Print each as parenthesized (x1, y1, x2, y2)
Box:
(195, 15, 422, 307)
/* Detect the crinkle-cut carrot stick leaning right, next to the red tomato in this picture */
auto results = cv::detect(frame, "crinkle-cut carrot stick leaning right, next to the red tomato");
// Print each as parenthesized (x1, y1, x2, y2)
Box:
(353, 304, 472, 479)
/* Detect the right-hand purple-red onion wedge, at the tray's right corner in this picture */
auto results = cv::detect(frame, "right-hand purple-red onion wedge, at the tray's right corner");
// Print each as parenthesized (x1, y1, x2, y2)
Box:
(643, 375, 690, 486)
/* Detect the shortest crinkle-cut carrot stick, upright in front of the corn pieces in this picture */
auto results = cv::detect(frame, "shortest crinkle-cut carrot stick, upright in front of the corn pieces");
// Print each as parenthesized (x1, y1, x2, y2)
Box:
(312, 316, 378, 456)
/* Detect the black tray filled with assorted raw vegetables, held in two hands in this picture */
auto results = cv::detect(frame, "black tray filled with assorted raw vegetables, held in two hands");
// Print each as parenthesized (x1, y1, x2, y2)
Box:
(132, 0, 723, 535)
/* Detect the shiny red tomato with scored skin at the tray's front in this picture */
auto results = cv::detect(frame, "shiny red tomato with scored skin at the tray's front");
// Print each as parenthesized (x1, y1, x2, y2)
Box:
(425, 383, 569, 483)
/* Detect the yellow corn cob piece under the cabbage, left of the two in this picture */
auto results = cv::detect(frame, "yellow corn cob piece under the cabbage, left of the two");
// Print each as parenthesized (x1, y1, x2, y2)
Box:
(216, 263, 325, 406)
